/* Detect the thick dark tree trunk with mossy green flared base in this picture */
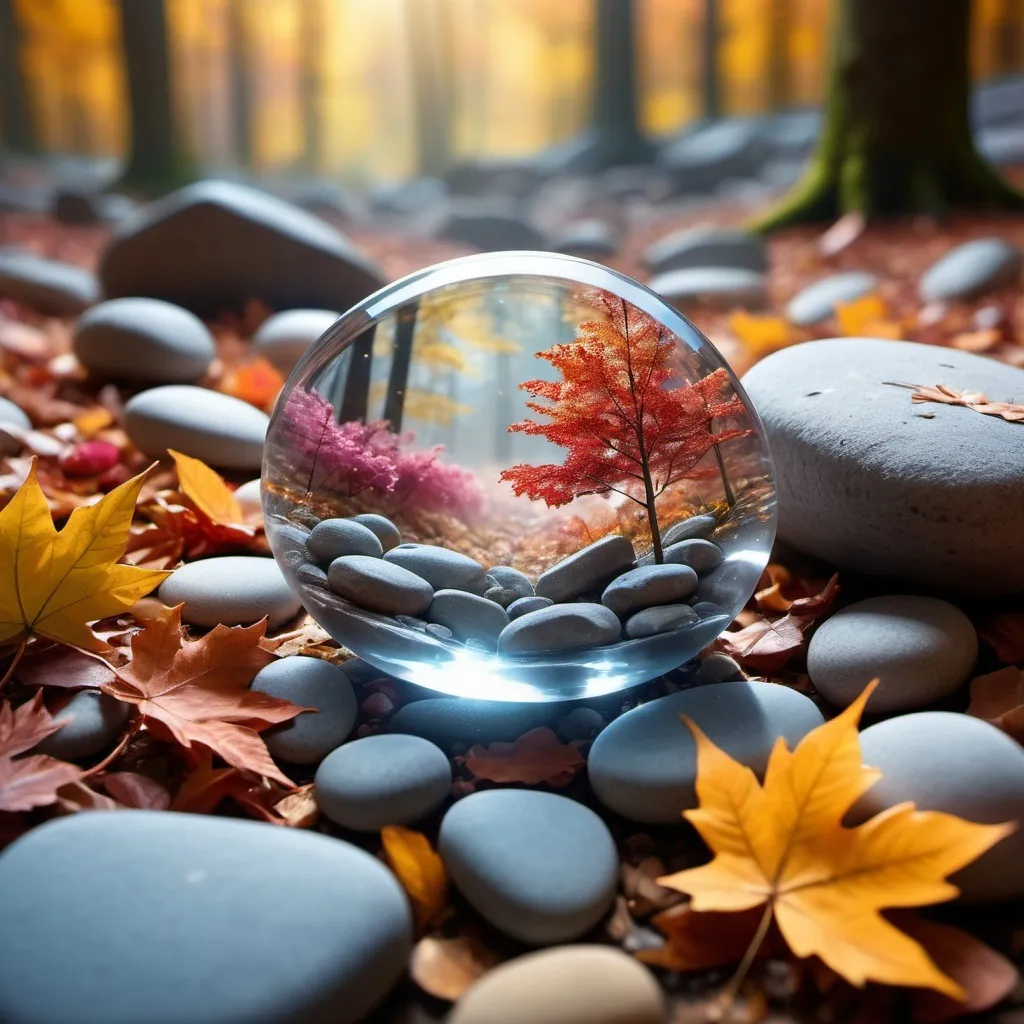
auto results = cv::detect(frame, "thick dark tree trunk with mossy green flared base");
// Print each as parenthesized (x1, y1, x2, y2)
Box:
(755, 0, 1024, 230)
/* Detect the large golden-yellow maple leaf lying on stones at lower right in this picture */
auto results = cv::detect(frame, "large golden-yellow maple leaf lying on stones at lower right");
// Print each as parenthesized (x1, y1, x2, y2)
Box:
(658, 680, 1014, 998)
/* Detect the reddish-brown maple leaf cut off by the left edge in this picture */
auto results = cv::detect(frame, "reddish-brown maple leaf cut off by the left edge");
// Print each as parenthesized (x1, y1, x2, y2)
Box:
(0, 690, 85, 811)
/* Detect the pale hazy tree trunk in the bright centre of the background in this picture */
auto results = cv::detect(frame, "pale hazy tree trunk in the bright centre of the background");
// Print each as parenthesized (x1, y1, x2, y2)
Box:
(406, 0, 452, 177)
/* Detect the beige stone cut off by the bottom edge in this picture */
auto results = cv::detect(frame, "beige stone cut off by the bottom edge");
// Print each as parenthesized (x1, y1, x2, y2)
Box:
(447, 943, 667, 1024)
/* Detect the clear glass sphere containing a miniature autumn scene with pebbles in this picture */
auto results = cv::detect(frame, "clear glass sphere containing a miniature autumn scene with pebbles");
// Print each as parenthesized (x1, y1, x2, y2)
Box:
(263, 253, 775, 701)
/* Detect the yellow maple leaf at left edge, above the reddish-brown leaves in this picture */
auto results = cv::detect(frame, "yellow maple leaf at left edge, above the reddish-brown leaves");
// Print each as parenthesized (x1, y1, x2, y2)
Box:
(0, 460, 170, 651)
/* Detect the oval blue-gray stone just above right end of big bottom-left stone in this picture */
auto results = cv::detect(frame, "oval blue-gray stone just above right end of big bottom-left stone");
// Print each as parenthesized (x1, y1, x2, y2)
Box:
(313, 734, 452, 831)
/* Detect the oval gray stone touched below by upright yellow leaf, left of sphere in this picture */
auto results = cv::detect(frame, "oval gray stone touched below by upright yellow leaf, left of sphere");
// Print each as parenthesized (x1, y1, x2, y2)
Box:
(125, 384, 269, 470)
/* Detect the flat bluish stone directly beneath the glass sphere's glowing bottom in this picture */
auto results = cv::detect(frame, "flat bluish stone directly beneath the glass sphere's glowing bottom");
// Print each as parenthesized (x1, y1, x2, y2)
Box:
(389, 697, 555, 750)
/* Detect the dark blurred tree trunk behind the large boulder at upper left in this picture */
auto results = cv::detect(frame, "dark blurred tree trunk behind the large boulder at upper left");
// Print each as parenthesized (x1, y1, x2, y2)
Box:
(118, 0, 190, 191)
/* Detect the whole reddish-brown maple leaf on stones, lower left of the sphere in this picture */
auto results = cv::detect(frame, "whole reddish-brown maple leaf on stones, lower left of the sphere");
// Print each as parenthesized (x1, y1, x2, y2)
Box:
(102, 605, 312, 788)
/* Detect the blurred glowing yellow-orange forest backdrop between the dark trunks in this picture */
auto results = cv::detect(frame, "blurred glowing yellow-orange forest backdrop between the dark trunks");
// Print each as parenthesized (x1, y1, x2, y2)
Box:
(0, 0, 1024, 185)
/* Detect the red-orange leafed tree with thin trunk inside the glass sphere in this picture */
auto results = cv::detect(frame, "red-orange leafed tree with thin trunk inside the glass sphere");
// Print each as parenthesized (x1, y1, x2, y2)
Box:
(501, 292, 750, 562)
